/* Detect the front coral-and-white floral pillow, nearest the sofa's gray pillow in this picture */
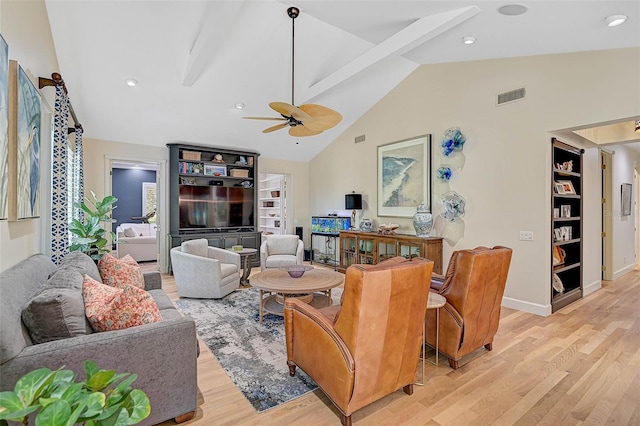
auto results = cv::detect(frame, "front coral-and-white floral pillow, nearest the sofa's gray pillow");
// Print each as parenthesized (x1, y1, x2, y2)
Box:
(82, 275, 162, 331)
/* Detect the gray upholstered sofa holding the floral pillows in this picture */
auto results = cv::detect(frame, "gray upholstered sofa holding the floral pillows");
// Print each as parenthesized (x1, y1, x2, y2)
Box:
(0, 252, 198, 425)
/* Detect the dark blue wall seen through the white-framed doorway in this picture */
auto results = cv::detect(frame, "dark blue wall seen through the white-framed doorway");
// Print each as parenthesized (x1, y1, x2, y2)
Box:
(111, 169, 156, 232)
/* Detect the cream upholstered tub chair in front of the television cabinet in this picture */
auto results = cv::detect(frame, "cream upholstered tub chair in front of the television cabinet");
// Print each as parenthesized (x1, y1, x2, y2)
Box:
(170, 238, 242, 299)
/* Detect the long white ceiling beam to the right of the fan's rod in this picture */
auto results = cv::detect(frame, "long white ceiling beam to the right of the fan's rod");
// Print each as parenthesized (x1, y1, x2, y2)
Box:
(304, 6, 480, 102)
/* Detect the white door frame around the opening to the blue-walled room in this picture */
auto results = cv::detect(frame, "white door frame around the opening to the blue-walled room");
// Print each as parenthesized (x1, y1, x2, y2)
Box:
(104, 155, 169, 272)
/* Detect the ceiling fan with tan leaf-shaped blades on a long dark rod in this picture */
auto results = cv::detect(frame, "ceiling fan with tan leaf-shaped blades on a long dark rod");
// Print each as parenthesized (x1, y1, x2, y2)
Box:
(244, 7, 342, 137)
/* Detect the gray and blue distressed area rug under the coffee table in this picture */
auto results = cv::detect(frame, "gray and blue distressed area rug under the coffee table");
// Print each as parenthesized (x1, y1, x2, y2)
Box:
(175, 288, 342, 412)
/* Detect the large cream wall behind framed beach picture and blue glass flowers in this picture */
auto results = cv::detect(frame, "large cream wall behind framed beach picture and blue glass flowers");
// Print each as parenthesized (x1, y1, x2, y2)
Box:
(309, 49, 640, 314)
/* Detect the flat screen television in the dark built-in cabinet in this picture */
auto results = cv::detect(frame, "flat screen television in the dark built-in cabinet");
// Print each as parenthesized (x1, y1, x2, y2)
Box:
(179, 185, 254, 231)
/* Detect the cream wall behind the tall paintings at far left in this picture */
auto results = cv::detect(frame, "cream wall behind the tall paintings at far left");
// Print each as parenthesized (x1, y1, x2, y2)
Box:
(0, 1, 58, 271)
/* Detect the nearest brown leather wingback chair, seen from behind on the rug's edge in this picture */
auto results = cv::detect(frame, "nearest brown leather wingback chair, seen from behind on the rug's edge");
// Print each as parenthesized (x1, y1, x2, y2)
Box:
(284, 257, 433, 425)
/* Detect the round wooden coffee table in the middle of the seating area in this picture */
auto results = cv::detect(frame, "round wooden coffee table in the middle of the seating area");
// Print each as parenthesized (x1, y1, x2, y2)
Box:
(251, 268, 344, 324)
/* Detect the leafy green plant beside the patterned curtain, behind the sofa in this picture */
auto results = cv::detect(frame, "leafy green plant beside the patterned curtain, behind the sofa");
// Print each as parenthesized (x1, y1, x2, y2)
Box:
(69, 191, 118, 262)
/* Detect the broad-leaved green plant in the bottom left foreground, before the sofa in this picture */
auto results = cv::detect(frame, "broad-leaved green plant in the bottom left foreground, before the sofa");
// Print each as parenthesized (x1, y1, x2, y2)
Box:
(0, 361, 151, 426)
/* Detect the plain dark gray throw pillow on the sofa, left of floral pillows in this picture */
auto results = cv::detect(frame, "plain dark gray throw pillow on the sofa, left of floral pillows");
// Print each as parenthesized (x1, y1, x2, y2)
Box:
(22, 268, 93, 343)
